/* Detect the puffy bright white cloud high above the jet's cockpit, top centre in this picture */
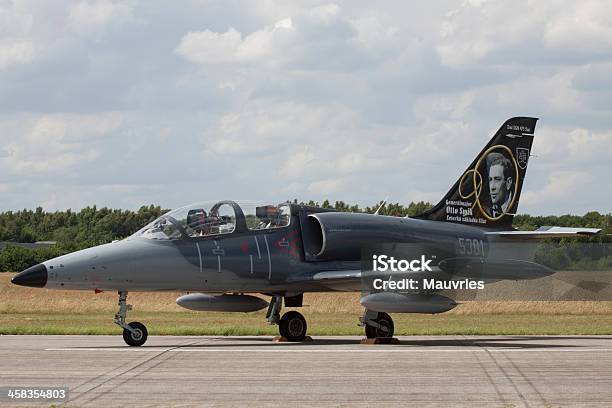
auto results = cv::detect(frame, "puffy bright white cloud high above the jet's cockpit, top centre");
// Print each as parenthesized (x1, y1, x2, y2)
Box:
(175, 4, 388, 70)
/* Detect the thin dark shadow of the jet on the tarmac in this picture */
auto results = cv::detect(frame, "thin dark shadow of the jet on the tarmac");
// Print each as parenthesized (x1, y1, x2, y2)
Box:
(74, 336, 612, 349)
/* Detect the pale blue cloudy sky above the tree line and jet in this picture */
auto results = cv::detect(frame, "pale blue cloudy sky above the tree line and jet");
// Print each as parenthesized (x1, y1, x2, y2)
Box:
(0, 0, 612, 214)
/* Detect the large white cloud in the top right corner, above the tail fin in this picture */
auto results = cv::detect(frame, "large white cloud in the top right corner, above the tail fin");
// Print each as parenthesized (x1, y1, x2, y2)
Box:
(436, 0, 612, 68)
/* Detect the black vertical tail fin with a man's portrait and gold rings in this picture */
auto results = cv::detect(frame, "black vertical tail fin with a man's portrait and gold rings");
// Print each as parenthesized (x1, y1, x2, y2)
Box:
(414, 117, 537, 229)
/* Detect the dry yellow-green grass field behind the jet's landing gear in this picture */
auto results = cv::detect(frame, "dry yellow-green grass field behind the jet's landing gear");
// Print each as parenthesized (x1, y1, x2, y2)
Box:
(0, 273, 612, 336)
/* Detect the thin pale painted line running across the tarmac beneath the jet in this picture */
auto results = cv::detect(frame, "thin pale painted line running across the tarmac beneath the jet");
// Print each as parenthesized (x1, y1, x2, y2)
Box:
(45, 346, 611, 353)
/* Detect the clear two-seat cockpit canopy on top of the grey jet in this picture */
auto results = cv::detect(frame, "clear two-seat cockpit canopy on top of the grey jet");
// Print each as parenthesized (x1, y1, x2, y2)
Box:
(132, 200, 291, 240)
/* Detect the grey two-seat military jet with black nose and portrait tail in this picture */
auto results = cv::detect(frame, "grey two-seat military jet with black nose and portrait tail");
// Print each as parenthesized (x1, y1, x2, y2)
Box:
(12, 117, 599, 346)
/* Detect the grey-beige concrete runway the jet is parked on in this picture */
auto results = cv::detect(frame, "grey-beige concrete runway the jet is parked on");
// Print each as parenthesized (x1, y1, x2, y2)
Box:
(0, 336, 612, 407)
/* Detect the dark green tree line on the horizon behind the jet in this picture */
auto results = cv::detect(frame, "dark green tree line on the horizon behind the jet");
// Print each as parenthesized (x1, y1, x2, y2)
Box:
(0, 200, 612, 271)
